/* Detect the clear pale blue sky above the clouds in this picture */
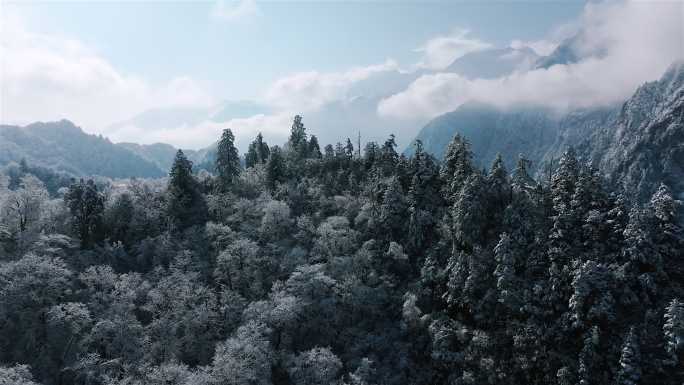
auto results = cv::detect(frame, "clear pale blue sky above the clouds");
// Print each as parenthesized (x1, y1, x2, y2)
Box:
(10, 1, 583, 99)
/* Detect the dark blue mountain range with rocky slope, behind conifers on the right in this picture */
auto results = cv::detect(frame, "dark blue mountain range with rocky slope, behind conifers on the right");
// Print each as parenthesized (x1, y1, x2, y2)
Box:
(405, 62, 684, 200)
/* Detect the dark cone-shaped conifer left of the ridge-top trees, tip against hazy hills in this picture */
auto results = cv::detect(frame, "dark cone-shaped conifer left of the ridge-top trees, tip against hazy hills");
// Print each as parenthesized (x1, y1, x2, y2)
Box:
(166, 150, 207, 230)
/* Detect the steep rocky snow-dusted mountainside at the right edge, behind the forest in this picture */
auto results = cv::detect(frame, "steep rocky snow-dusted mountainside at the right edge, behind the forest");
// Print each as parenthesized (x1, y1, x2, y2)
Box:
(584, 62, 684, 199)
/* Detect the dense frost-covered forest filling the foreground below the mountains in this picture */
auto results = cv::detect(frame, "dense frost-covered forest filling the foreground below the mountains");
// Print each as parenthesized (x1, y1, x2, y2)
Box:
(0, 116, 684, 385)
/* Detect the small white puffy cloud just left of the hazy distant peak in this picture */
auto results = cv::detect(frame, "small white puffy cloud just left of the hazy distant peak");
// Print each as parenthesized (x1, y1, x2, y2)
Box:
(415, 30, 492, 70)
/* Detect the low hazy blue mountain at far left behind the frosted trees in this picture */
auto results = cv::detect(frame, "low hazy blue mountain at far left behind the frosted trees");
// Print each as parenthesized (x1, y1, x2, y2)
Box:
(0, 120, 166, 178)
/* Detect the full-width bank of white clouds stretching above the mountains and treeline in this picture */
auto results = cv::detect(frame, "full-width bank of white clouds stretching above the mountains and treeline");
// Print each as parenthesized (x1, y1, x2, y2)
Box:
(0, 0, 684, 149)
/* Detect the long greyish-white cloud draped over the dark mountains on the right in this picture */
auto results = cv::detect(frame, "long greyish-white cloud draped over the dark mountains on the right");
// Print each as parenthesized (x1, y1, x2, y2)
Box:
(378, 1, 684, 119)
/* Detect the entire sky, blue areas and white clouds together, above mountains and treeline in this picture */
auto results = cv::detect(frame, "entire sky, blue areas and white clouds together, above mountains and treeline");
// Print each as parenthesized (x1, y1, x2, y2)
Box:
(0, 0, 684, 148)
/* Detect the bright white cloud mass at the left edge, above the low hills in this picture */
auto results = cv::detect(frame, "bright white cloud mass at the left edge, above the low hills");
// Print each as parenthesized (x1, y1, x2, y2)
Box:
(0, 13, 214, 140)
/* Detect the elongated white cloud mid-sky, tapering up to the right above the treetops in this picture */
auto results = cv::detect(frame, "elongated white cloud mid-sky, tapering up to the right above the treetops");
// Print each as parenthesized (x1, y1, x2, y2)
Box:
(264, 59, 399, 112)
